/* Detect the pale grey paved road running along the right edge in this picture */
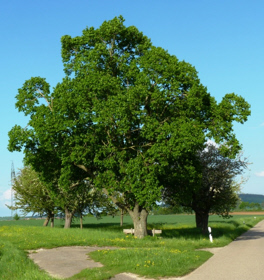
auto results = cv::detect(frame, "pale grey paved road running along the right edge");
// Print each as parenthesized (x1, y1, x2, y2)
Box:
(182, 220, 264, 280)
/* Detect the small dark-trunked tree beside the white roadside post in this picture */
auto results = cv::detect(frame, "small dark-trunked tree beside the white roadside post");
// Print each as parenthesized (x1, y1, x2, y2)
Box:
(164, 144, 248, 233)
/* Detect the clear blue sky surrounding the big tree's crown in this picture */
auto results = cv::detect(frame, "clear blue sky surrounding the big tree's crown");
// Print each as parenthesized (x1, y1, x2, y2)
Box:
(0, 0, 264, 216)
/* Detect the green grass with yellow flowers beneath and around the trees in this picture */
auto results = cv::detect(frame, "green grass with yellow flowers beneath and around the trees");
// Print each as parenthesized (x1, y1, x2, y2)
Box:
(0, 215, 264, 280)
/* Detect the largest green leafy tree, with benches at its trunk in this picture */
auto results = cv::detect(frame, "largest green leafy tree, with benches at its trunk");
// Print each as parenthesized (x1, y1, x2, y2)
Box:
(8, 17, 249, 237)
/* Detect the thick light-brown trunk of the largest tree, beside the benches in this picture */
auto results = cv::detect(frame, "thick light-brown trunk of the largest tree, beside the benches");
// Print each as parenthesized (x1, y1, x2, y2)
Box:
(128, 204, 148, 238)
